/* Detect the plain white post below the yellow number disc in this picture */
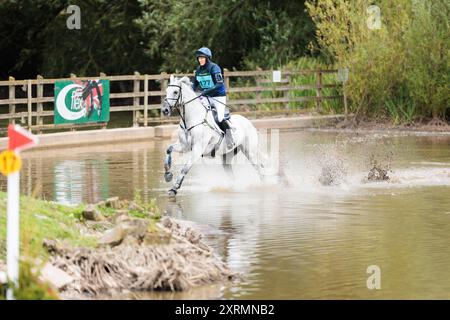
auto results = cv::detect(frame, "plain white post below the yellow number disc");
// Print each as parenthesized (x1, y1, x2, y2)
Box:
(6, 171, 20, 300)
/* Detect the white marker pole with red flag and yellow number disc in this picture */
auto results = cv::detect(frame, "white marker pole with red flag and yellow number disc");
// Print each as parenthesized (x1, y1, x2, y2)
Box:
(0, 124, 39, 300)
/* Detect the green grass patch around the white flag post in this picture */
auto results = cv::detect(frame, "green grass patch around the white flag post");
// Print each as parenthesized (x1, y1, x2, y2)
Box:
(0, 192, 97, 300)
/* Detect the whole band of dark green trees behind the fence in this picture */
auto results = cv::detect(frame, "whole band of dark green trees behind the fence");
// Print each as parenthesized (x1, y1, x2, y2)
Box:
(0, 0, 314, 78)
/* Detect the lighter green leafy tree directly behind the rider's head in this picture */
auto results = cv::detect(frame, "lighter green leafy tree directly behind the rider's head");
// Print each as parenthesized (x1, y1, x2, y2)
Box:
(137, 0, 313, 72)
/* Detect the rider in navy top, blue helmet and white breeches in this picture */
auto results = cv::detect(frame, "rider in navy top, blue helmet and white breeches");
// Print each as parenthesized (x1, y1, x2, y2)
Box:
(192, 47, 234, 148)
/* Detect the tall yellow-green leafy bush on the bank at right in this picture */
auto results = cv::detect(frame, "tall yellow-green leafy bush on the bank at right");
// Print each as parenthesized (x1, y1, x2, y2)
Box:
(306, 0, 450, 121)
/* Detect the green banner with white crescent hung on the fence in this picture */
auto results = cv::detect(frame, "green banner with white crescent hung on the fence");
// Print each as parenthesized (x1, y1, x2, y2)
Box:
(55, 79, 109, 124)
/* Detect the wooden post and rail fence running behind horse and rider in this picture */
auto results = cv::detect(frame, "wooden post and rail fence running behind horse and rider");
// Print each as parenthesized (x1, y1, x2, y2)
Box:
(0, 69, 343, 133)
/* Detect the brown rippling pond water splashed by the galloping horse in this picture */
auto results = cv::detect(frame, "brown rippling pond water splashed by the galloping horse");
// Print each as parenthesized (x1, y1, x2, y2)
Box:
(1, 130, 450, 299)
